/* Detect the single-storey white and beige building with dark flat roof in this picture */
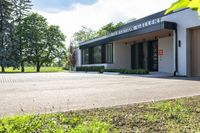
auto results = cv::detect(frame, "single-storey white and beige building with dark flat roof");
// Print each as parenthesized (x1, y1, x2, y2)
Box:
(77, 9, 200, 76)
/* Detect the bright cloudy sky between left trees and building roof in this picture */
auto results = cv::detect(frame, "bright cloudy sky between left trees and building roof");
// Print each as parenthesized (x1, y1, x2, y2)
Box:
(32, 0, 177, 45)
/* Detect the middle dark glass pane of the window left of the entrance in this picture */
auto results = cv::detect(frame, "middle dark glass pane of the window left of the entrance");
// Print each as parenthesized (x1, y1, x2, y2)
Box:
(93, 46, 102, 64)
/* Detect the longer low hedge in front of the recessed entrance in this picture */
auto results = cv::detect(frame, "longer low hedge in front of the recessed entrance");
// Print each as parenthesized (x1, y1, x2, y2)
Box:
(104, 69, 149, 74)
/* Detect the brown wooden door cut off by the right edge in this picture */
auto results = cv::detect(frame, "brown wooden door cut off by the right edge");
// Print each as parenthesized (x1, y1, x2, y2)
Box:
(191, 28, 200, 76)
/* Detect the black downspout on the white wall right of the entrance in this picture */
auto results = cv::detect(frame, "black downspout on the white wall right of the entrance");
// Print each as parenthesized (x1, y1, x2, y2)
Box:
(174, 26, 178, 76)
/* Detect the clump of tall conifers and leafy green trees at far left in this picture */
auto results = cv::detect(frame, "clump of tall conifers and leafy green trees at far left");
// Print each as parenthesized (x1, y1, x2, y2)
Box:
(0, 0, 67, 72)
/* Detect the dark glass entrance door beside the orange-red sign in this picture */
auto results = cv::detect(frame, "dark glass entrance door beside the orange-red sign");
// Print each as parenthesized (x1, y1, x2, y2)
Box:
(148, 41, 158, 71)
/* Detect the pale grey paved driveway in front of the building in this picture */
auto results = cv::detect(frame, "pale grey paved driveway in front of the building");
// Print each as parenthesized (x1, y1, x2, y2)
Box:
(0, 73, 200, 116)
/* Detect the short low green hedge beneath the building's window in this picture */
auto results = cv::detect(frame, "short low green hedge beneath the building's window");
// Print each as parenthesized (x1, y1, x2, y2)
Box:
(76, 66, 105, 73)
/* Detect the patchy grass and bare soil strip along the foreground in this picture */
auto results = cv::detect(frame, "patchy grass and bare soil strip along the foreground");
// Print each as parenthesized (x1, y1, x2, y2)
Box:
(0, 96, 200, 133)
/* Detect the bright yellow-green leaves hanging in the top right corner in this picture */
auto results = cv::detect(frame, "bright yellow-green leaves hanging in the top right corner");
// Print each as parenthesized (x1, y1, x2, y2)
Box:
(165, 0, 200, 15)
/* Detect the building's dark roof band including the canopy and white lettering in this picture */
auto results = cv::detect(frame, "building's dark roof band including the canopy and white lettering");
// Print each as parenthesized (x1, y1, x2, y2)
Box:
(79, 10, 181, 48)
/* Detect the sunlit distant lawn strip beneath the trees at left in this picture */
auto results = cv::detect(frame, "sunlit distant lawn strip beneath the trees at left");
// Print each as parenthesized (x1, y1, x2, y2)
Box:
(0, 67, 64, 73)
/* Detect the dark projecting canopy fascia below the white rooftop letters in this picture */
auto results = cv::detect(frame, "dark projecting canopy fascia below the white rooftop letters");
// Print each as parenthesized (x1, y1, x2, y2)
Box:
(79, 20, 177, 48)
